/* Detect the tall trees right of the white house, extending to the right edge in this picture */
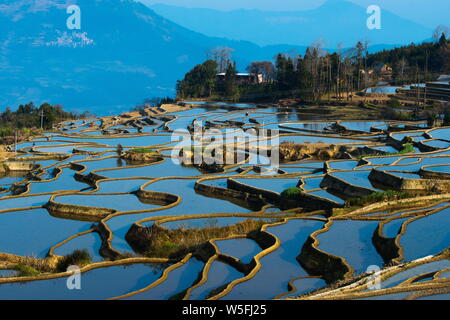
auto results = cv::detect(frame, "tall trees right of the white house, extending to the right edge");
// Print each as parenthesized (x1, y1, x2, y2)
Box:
(260, 34, 450, 101)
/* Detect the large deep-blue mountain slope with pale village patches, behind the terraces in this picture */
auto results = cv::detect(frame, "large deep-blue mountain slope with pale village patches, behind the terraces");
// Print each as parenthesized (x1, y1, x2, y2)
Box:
(0, 0, 432, 115)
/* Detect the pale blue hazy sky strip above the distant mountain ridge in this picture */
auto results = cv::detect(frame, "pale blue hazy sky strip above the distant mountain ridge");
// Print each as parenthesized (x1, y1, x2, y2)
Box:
(139, 0, 450, 28)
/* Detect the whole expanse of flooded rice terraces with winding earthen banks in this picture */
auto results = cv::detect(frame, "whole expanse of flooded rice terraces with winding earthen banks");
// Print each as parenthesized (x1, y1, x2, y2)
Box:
(0, 103, 450, 300)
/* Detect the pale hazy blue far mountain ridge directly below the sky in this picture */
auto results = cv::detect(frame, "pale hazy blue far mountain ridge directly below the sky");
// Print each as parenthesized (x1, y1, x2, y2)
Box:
(148, 0, 432, 48)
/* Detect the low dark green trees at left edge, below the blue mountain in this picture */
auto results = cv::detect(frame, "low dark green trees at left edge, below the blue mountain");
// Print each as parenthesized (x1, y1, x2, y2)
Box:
(0, 102, 91, 142)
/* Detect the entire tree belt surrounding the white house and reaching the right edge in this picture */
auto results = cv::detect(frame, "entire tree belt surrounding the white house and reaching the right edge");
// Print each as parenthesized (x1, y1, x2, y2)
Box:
(177, 29, 450, 102)
